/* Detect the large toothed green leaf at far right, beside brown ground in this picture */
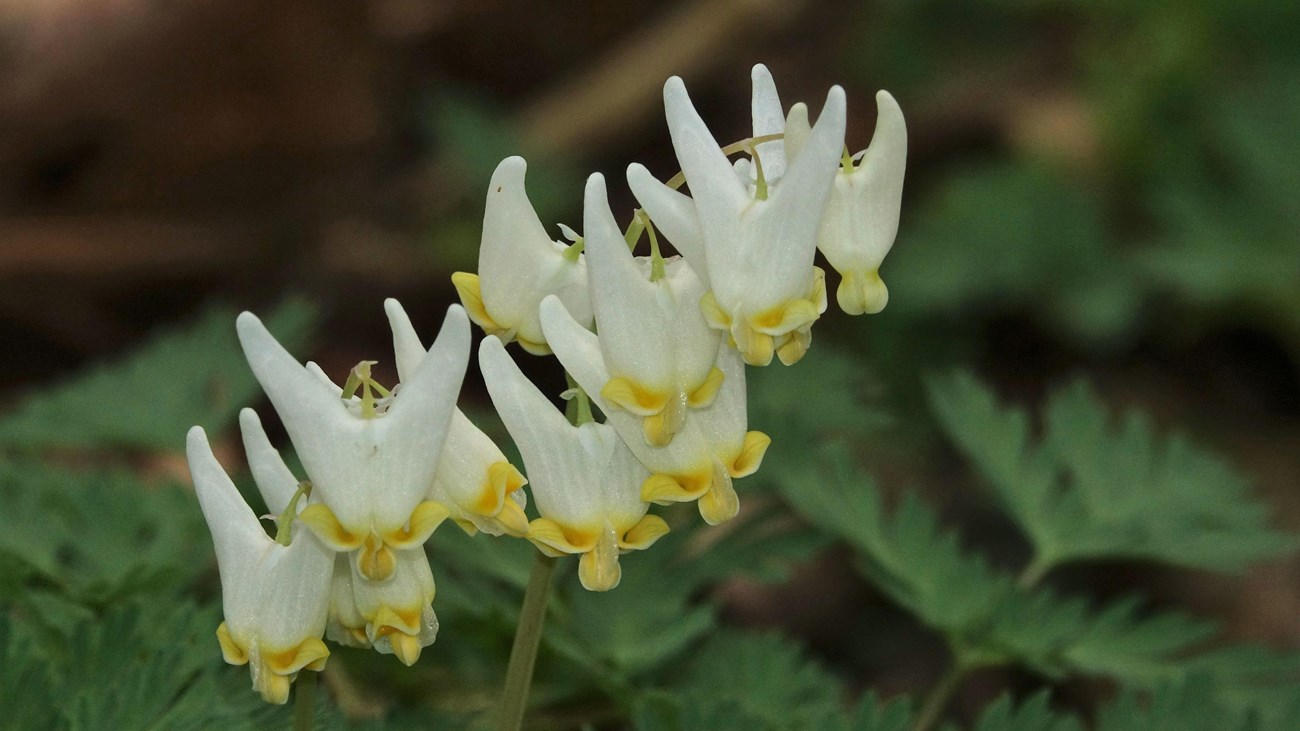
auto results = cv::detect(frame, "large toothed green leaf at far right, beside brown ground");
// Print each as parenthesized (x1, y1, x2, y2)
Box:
(931, 375, 1295, 571)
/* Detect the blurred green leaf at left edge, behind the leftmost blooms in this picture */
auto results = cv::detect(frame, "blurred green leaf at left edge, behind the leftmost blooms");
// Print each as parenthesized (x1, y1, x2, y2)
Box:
(0, 302, 315, 451)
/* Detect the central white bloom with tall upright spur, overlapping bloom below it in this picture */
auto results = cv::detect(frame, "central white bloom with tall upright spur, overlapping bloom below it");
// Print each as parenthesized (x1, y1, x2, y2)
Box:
(582, 174, 723, 446)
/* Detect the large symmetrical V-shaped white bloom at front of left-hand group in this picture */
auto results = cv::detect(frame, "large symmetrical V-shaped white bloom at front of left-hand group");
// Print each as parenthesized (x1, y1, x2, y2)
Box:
(238, 299, 469, 581)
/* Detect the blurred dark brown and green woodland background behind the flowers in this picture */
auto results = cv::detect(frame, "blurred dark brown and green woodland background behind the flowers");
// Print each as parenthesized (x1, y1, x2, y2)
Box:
(0, 0, 1300, 723)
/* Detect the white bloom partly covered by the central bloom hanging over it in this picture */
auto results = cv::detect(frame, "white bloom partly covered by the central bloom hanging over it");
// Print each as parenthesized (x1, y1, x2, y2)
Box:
(542, 298, 771, 524)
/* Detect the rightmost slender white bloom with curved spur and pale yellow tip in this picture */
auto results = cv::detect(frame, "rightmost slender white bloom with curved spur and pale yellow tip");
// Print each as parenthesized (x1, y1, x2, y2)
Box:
(787, 91, 907, 315)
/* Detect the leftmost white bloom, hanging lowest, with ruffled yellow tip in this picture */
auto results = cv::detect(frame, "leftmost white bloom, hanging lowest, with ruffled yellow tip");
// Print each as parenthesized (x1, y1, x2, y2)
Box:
(186, 427, 334, 704)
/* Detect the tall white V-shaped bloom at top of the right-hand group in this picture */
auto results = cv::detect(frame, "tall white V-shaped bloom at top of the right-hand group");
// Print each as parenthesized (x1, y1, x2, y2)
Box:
(628, 66, 845, 366)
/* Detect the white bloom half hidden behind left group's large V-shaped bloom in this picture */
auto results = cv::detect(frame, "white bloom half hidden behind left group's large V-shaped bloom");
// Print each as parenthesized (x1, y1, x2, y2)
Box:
(384, 299, 528, 537)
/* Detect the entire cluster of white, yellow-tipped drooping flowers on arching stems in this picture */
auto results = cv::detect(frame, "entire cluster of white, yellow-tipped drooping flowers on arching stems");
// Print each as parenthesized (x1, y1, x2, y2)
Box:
(187, 65, 906, 702)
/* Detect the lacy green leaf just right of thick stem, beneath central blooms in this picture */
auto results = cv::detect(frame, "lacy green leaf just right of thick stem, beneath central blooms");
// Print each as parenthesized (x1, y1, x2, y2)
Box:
(546, 499, 824, 688)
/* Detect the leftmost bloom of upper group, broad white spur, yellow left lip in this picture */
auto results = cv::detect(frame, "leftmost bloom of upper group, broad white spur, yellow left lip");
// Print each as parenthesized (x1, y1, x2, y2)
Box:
(451, 157, 592, 355)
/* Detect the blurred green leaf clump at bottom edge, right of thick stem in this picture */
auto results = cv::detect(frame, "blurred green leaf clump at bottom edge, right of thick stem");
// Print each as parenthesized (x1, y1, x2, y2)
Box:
(633, 631, 842, 731)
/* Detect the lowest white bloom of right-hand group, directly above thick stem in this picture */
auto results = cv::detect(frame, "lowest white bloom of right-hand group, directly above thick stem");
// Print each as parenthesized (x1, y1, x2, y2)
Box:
(478, 335, 668, 592)
